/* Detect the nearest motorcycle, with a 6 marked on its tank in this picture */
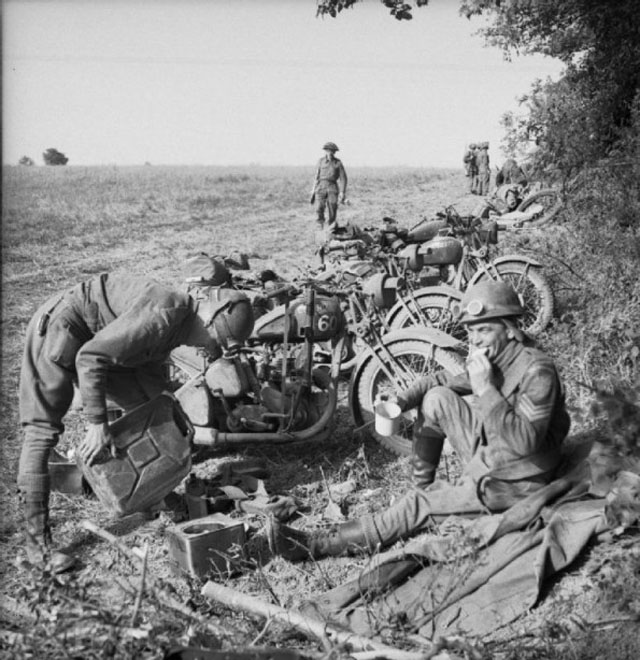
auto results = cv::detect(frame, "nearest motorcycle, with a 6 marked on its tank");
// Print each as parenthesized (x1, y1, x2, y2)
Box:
(167, 280, 464, 450)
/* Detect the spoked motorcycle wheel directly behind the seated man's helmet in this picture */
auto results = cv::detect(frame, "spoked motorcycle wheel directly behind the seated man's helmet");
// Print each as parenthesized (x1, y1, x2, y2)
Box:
(476, 261, 555, 337)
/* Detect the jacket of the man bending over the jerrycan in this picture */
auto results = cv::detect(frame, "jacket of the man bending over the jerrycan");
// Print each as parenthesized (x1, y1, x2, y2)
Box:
(54, 274, 196, 423)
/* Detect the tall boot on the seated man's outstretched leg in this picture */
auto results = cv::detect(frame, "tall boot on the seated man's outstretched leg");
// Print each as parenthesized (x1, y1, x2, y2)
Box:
(267, 518, 379, 561)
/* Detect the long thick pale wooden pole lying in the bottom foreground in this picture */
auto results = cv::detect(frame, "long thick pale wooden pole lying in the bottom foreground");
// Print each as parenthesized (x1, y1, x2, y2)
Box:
(201, 580, 428, 660)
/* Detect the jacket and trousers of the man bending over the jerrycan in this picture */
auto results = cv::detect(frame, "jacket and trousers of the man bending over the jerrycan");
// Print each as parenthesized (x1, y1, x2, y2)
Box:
(18, 274, 196, 491)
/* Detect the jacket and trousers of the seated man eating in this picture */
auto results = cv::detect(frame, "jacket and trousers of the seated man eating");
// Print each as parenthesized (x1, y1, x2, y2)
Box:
(362, 340, 570, 547)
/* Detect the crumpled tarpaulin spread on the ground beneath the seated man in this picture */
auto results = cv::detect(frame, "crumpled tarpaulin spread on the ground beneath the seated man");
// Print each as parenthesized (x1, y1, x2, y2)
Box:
(302, 444, 640, 638)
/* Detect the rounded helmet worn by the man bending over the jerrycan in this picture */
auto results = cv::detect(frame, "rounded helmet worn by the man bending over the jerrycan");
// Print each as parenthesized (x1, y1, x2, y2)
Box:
(198, 289, 254, 346)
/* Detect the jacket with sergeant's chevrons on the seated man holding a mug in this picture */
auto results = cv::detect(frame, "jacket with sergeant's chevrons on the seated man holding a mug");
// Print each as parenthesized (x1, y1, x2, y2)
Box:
(399, 340, 570, 475)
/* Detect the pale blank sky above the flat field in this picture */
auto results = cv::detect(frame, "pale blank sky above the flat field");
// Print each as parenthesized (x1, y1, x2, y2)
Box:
(3, 0, 561, 166)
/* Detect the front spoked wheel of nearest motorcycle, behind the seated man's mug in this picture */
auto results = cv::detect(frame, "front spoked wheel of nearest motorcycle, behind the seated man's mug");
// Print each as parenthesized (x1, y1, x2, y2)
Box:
(349, 338, 464, 456)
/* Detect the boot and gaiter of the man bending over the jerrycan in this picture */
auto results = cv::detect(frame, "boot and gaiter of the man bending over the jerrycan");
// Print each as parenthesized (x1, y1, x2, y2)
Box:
(20, 475, 75, 573)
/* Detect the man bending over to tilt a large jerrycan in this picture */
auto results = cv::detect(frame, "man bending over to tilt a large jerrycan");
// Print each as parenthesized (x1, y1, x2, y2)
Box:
(17, 274, 253, 572)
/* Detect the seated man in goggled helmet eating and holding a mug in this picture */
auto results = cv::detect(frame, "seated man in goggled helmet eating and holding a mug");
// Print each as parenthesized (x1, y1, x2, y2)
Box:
(268, 281, 570, 561)
